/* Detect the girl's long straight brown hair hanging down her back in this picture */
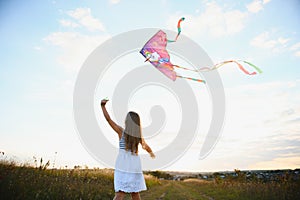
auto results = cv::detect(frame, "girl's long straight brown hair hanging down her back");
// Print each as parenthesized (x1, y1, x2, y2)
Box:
(124, 111, 142, 154)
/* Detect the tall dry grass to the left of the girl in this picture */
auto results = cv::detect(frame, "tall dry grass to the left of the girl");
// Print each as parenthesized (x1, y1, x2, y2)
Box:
(0, 163, 114, 200)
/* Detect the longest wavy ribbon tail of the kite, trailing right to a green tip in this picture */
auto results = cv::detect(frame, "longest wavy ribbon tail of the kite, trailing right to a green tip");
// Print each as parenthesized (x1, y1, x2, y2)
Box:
(173, 60, 262, 75)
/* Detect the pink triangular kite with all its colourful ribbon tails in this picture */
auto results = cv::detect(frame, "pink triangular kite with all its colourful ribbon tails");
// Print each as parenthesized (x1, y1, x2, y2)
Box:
(140, 17, 262, 83)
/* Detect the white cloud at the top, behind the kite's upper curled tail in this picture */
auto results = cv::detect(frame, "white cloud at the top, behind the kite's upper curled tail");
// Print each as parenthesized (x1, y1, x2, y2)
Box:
(168, 2, 247, 37)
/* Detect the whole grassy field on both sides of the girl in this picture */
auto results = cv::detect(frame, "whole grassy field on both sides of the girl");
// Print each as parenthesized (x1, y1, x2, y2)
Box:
(0, 162, 300, 200)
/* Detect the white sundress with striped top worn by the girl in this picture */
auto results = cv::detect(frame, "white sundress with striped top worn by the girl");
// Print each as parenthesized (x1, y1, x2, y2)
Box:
(114, 133, 147, 193)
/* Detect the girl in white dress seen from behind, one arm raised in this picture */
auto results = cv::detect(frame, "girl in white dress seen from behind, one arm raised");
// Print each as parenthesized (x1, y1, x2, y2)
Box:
(101, 99, 155, 200)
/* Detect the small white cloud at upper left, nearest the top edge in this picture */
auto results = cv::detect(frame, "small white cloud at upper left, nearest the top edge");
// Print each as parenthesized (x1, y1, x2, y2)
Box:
(67, 8, 105, 31)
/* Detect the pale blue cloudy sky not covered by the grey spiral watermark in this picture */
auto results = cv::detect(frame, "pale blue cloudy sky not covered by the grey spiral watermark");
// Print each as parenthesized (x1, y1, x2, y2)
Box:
(0, 0, 300, 171)
